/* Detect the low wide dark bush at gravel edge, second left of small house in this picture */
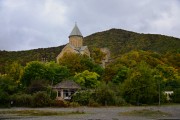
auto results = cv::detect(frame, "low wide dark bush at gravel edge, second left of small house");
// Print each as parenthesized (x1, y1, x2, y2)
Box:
(11, 94, 33, 107)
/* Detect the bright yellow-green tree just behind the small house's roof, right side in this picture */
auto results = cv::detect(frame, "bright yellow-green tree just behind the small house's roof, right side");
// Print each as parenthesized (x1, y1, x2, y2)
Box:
(74, 70, 100, 88)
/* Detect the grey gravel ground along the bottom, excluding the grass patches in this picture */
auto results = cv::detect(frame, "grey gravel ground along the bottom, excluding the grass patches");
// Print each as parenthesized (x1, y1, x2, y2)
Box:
(0, 105, 180, 120)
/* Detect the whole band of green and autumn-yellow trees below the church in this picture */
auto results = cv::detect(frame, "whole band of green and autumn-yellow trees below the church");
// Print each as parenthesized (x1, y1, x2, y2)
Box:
(0, 50, 180, 107)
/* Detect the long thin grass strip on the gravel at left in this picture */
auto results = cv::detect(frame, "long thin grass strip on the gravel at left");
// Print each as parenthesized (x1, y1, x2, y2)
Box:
(0, 110, 85, 116)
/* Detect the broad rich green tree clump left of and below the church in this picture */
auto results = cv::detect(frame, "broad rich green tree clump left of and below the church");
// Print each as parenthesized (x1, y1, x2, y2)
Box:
(21, 61, 69, 90)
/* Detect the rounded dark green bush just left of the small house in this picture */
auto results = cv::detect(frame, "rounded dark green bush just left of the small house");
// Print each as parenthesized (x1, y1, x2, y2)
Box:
(32, 91, 51, 107)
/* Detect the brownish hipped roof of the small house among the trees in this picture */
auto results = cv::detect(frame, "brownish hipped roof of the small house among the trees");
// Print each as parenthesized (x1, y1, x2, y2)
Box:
(53, 80, 81, 89)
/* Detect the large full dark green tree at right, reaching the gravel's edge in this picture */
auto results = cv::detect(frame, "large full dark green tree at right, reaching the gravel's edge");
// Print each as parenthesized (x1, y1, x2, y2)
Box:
(123, 62, 158, 104)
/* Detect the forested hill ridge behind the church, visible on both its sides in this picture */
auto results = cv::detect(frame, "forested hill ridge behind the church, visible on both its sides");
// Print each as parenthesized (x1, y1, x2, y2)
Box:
(0, 29, 180, 73)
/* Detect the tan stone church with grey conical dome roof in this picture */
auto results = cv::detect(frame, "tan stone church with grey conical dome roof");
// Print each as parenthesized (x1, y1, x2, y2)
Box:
(56, 24, 90, 63)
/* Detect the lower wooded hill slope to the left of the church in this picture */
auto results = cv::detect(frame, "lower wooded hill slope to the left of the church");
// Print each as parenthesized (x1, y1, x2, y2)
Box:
(0, 45, 65, 73)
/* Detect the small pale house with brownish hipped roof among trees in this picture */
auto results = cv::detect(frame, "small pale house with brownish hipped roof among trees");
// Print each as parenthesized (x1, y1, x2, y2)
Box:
(53, 80, 81, 100)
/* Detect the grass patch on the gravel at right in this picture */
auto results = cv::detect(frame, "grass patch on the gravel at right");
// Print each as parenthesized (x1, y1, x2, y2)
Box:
(120, 109, 171, 117)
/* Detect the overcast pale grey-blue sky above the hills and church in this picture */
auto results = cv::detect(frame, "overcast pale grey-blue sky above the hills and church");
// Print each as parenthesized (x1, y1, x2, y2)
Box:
(0, 0, 180, 51)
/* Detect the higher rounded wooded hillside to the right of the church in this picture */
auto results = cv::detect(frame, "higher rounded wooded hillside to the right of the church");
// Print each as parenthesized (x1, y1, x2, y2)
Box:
(85, 29, 180, 57)
